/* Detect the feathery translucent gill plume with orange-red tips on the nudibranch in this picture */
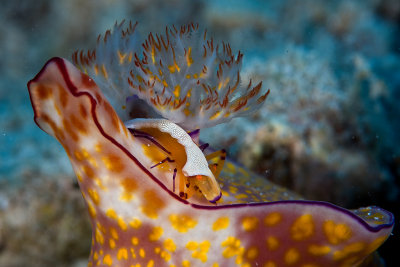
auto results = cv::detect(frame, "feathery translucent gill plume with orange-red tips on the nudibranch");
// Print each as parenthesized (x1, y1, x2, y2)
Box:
(73, 22, 269, 130)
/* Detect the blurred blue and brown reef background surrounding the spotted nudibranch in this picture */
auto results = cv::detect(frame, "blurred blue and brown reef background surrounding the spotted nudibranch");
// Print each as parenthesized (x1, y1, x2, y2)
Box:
(0, 0, 400, 267)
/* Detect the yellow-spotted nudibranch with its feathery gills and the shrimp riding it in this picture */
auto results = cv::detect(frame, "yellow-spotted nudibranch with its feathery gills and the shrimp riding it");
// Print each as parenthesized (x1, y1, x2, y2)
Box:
(28, 23, 393, 267)
